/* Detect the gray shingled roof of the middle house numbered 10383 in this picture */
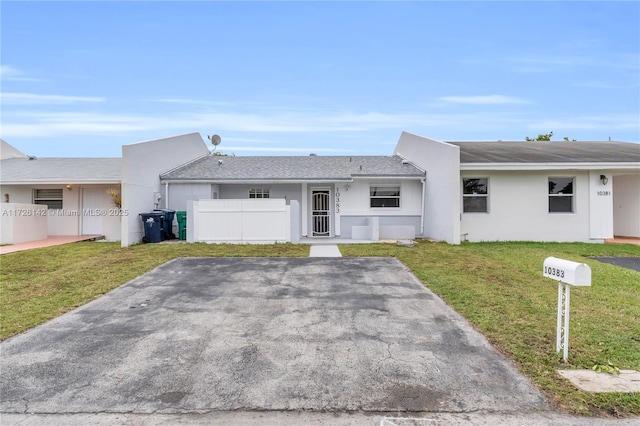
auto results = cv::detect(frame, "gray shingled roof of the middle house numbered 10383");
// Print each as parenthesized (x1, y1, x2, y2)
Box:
(160, 155, 425, 181)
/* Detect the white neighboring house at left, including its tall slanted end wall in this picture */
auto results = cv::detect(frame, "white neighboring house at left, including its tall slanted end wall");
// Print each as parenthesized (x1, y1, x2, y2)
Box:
(0, 133, 209, 245)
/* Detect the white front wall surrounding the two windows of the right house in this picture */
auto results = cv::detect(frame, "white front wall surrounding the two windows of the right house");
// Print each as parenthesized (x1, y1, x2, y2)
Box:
(459, 170, 590, 242)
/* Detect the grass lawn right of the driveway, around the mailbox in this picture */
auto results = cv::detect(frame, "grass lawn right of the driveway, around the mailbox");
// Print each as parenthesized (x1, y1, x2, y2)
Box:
(340, 242, 640, 416)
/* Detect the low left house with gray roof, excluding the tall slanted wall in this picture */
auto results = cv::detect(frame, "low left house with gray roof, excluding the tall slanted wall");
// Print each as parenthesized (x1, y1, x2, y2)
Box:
(0, 141, 121, 244)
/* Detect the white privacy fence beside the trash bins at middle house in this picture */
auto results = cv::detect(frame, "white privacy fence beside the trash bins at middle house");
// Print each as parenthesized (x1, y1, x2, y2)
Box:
(187, 199, 297, 243)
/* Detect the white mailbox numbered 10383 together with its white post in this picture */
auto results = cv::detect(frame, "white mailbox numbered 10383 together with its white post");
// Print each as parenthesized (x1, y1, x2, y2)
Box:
(543, 257, 591, 362)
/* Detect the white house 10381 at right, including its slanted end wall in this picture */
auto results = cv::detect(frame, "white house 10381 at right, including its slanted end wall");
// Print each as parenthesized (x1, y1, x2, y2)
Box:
(395, 133, 640, 244)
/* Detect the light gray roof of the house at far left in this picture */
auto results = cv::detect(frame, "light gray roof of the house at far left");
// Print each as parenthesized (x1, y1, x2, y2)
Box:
(0, 158, 122, 185)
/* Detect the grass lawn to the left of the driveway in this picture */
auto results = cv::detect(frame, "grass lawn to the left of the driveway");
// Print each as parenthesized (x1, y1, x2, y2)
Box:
(0, 242, 309, 340)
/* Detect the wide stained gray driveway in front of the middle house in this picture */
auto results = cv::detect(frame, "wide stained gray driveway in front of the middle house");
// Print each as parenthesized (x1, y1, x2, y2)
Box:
(0, 258, 548, 414)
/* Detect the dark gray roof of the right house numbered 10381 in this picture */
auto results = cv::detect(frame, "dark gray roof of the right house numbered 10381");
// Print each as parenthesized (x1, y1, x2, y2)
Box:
(447, 141, 640, 164)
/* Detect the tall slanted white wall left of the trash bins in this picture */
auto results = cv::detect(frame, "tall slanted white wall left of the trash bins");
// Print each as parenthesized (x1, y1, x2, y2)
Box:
(121, 133, 209, 247)
